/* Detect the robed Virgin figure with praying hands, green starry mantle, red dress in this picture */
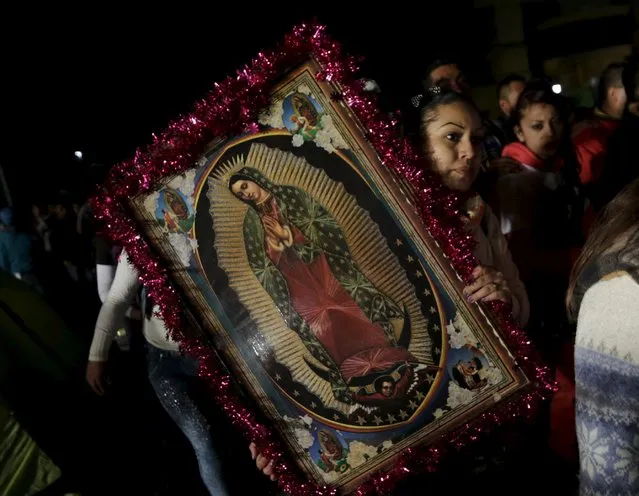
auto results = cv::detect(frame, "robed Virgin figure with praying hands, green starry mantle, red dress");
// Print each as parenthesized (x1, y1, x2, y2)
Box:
(228, 167, 430, 405)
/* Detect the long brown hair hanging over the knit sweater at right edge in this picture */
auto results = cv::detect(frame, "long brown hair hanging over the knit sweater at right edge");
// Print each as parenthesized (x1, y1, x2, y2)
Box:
(566, 179, 639, 319)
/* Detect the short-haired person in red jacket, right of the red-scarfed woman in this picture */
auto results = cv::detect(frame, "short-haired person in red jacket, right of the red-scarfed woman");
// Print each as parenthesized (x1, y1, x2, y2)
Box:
(572, 63, 627, 185)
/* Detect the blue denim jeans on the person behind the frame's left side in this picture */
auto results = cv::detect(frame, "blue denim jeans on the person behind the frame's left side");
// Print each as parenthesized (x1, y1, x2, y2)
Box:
(147, 344, 229, 496)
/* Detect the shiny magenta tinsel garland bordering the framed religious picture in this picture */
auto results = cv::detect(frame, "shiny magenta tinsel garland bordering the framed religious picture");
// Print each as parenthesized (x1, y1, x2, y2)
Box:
(92, 24, 555, 496)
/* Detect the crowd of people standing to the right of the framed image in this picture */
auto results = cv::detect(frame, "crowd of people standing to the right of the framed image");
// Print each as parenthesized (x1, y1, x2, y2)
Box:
(414, 60, 639, 494)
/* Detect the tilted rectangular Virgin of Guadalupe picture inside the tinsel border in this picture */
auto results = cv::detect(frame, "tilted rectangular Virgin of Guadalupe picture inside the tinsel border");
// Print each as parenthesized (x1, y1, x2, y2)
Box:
(130, 60, 529, 493)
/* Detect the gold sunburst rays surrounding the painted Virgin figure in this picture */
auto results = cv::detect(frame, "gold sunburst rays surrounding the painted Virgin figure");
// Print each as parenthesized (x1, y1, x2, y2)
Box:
(208, 143, 433, 412)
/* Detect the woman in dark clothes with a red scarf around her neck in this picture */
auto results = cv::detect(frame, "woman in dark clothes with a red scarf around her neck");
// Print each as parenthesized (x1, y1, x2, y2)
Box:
(491, 81, 584, 350)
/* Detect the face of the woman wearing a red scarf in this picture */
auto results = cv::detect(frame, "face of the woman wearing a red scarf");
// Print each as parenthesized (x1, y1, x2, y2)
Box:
(515, 103, 564, 159)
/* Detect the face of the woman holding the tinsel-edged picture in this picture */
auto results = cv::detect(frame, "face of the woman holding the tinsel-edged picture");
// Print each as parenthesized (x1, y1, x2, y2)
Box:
(425, 102, 484, 191)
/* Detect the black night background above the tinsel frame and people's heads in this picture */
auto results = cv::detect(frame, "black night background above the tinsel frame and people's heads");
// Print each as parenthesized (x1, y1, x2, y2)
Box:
(0, 0, 637, 201)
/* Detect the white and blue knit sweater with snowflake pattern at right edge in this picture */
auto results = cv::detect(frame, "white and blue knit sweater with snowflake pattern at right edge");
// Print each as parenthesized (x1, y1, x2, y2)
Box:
(575, 272, 639, 496)
